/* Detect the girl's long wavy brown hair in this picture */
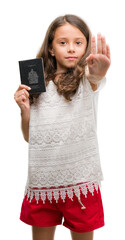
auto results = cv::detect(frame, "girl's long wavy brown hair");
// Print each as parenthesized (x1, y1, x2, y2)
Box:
(29, 15, 91, 101)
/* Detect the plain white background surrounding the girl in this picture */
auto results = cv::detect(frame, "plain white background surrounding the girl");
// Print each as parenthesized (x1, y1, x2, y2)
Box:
(0, 0, 125, 240)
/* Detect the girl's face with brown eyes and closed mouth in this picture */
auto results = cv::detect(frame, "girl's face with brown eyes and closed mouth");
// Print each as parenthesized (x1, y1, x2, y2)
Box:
(50, 23, 87, 72)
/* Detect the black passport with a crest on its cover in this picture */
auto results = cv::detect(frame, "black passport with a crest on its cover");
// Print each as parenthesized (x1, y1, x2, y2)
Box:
(19, 58, 46, 94)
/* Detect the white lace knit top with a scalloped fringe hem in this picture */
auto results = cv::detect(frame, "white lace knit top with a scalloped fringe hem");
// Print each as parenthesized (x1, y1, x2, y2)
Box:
(26, 78, 105, 202)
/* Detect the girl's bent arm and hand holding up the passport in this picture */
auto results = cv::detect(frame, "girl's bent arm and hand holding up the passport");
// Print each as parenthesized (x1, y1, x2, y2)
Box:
(14, 85, 30, 142)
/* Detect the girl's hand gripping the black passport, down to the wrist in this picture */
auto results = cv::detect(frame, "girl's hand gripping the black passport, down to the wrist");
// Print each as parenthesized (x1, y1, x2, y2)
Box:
(14, 84, 31, 113)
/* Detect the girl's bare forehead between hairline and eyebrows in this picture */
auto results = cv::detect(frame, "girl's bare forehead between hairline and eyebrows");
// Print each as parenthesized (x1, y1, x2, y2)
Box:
(54, 23, 86, 39)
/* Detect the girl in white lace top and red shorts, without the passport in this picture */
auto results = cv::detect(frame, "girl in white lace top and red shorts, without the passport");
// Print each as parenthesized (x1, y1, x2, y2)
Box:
(15, 15, 110, 240)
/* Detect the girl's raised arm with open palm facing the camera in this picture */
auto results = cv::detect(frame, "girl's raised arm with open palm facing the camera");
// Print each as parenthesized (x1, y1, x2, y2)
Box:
(86, 34, 111, 91)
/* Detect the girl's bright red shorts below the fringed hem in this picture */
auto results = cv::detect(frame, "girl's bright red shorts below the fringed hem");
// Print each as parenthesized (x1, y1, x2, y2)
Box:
(20, 186, 104, 232)
